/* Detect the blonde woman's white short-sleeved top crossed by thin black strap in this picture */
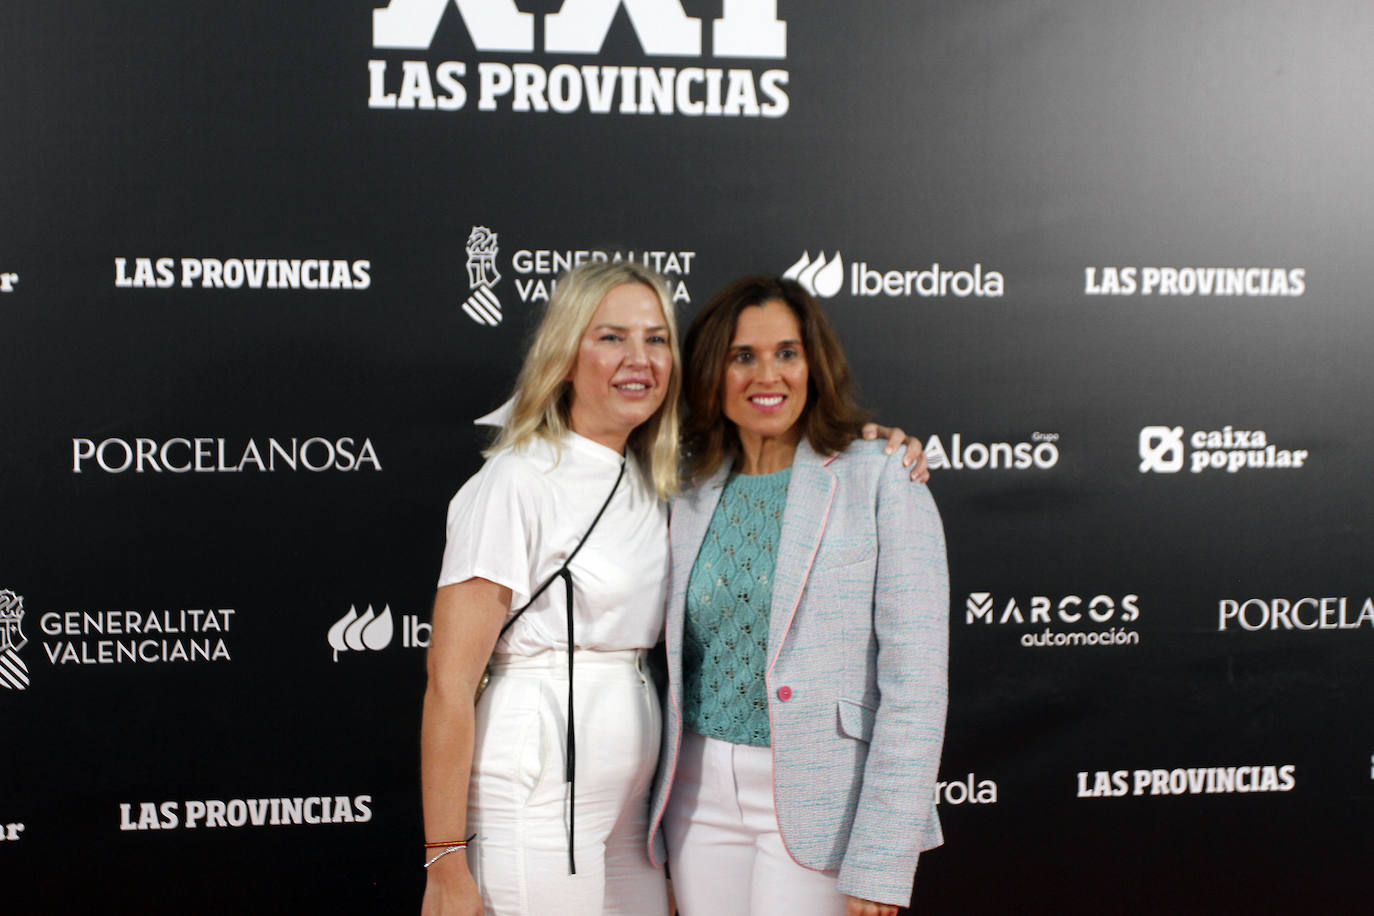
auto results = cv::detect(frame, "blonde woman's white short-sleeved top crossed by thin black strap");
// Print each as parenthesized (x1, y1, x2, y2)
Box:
(438, 434, 668, 655)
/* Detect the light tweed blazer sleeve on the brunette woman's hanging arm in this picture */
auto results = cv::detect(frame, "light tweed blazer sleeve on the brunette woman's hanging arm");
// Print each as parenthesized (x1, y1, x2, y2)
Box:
(838, 456, 949, 906)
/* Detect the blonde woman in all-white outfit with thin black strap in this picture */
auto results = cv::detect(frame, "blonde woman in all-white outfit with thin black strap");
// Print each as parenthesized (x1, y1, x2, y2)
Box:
(420, 264, 682, 916)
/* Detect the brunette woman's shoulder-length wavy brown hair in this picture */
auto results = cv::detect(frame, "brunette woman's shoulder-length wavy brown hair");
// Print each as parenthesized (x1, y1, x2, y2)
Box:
(683, 276, 867, 481)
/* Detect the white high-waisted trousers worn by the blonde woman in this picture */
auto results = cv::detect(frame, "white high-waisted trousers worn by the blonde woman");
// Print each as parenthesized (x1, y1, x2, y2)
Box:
(467, 650, 668, 916)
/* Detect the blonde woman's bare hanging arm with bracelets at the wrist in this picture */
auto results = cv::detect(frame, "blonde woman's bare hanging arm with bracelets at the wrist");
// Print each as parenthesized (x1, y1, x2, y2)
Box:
(420, 578, 511, 916)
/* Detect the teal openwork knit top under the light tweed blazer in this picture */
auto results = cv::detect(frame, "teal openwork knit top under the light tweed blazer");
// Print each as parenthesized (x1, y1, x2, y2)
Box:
(683, 468, 791, 747)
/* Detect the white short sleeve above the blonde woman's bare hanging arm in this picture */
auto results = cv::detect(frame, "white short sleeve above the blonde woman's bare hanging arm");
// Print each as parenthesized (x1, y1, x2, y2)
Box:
(438, 452, 544, 607)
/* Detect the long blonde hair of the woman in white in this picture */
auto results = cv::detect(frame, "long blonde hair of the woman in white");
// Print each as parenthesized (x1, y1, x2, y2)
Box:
(486, 261, 683, 499)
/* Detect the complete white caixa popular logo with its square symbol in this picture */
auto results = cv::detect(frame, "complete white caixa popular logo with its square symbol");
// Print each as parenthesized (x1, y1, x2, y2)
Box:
(1139, 426, 1309, 474)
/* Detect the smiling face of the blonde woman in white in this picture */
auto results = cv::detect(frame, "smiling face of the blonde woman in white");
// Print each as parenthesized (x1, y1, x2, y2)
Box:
(567, 283, 673, 452)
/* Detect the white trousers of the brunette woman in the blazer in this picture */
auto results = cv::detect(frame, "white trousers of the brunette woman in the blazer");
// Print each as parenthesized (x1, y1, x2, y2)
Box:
(664, 731, 845, 916)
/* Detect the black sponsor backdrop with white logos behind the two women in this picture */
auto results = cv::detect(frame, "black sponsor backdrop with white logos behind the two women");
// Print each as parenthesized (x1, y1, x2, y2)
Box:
(0, 0, 1374, 915)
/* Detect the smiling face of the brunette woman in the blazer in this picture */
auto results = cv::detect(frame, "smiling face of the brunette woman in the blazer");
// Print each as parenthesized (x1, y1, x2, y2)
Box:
(720, 299, 808, 455)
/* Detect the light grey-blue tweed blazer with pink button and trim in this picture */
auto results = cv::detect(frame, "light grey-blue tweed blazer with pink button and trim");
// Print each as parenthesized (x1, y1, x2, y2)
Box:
(649, 439, 949, 905)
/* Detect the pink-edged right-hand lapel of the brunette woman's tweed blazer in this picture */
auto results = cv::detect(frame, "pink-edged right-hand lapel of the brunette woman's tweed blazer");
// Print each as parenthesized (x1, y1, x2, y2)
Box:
(768, 438, 835, 672)
